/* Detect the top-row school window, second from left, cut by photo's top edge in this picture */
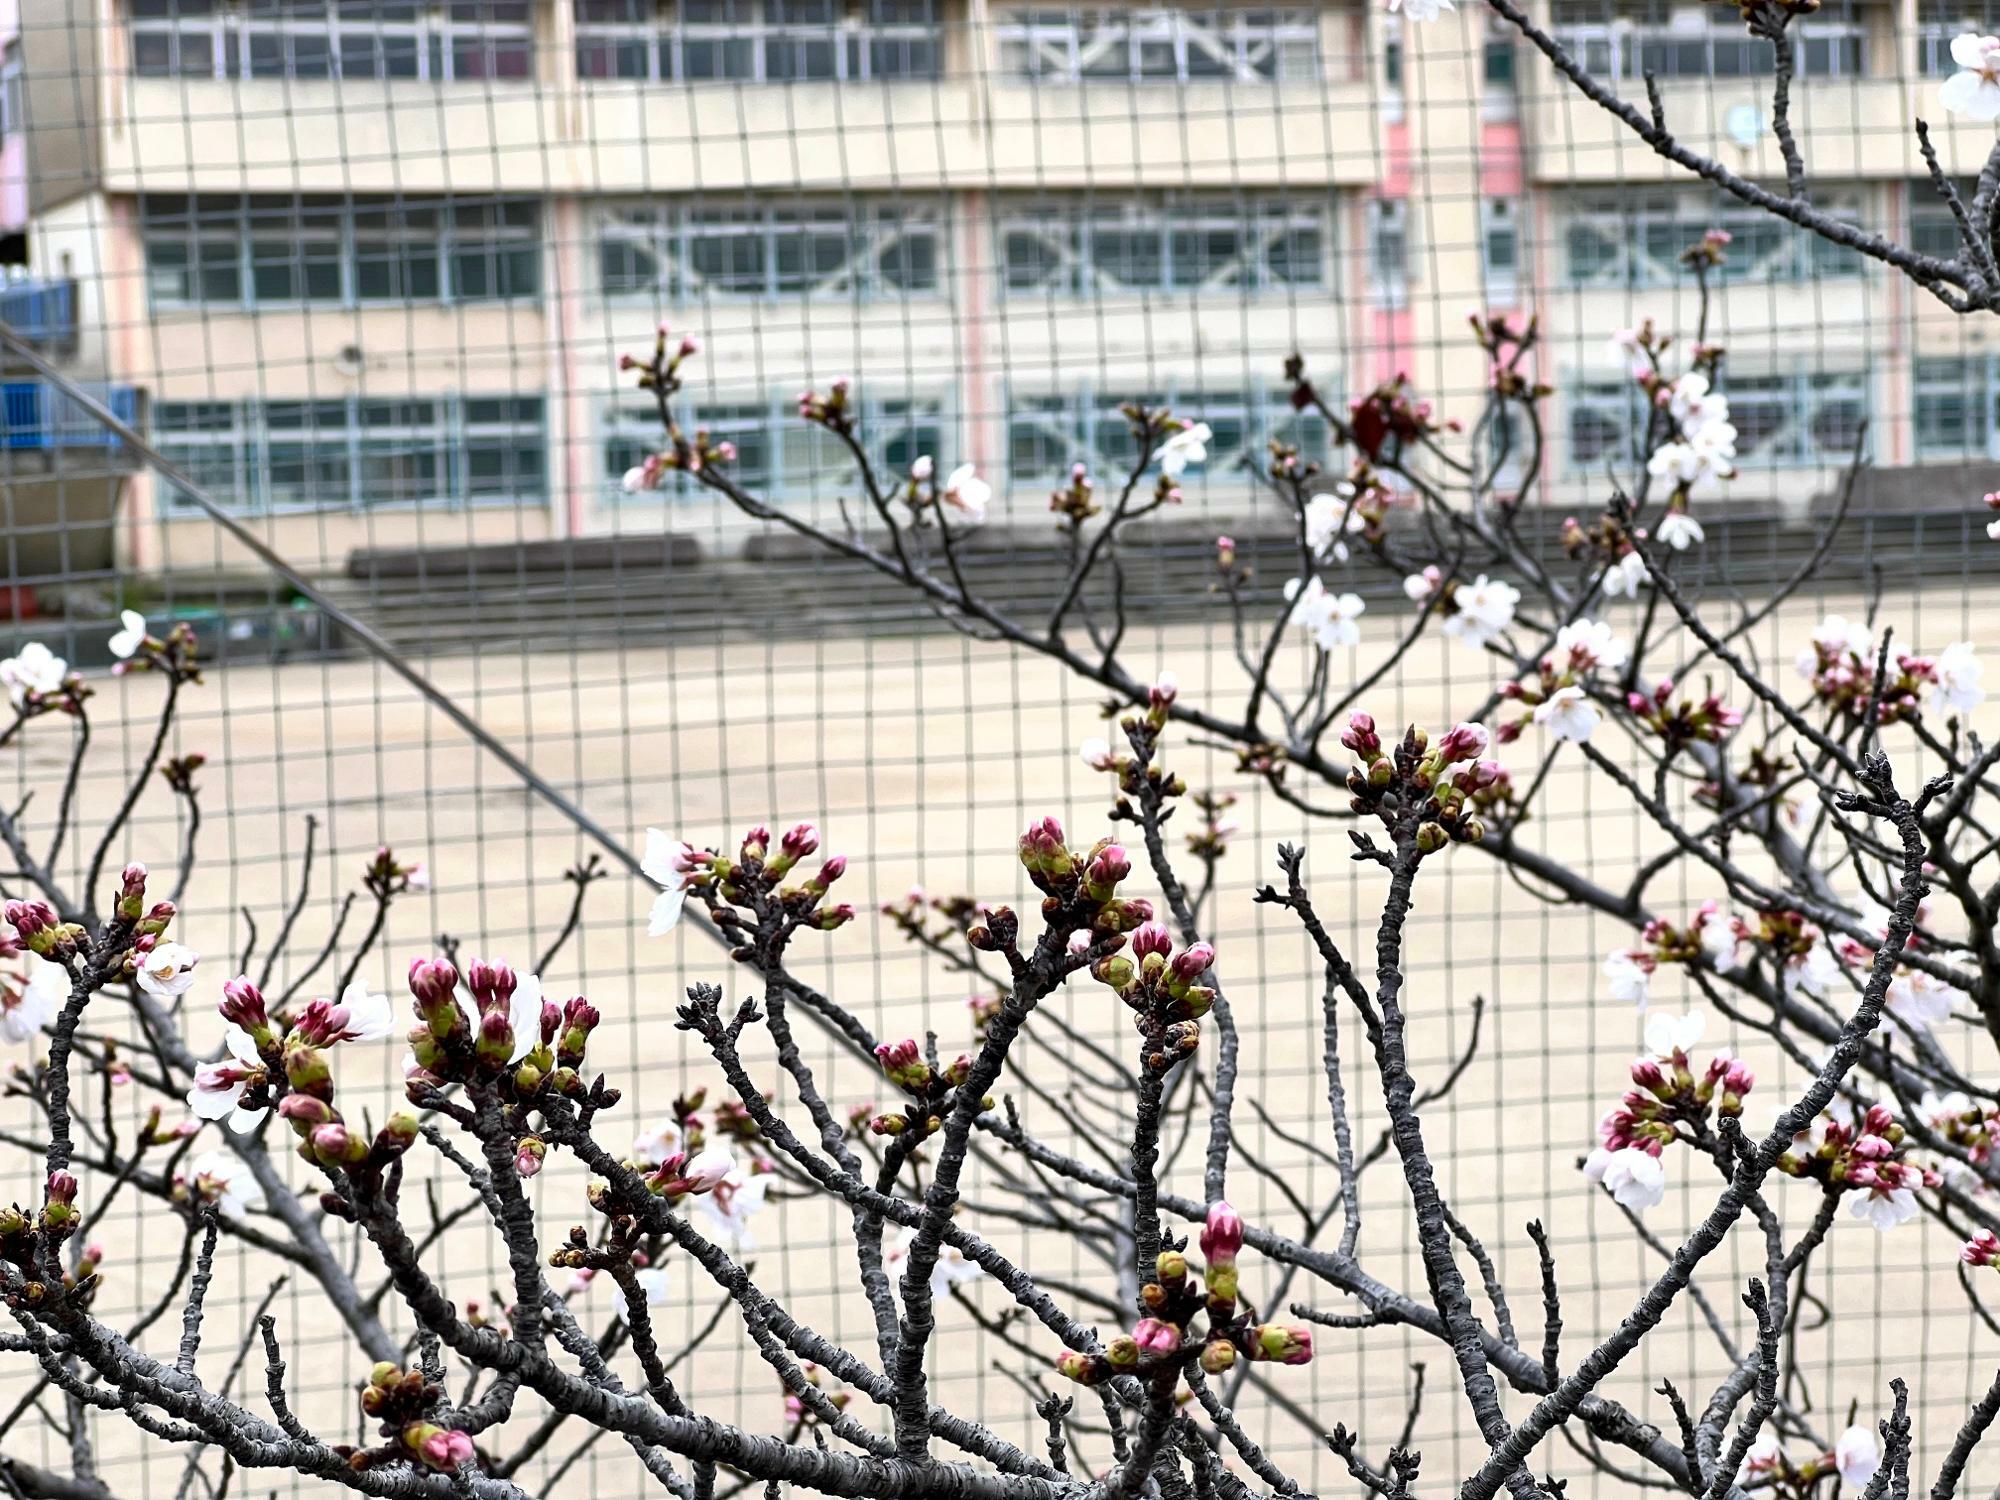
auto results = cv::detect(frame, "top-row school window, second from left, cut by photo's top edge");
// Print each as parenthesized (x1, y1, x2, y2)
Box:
(574, 0, 944, 82)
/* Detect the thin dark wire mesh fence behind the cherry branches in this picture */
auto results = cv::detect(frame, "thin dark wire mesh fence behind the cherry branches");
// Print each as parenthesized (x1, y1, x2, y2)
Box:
(0, 0, 2000, 1496)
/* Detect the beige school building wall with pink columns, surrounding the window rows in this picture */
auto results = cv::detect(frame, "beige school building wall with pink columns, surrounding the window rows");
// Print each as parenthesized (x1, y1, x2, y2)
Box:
(15, 0, 1990, 568)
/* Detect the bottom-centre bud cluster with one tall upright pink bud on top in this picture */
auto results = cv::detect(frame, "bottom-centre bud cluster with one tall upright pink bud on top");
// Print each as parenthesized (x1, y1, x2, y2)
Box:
(1056, 1202, 1312, 1386)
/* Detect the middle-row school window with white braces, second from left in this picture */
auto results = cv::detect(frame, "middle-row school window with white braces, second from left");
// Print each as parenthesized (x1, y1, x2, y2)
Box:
(598, 202, 942, 298)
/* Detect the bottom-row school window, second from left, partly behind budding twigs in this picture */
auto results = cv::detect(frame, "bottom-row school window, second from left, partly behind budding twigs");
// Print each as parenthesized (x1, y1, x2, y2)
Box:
(604, 392, 946, 504)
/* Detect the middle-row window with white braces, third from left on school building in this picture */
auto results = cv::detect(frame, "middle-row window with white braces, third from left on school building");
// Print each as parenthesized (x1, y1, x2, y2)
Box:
(998, 194, 1332, 296)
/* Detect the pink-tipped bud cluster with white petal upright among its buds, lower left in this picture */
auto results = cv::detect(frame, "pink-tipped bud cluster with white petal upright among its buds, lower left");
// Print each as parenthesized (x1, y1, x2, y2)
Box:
(406, 958, 600, 1120)
